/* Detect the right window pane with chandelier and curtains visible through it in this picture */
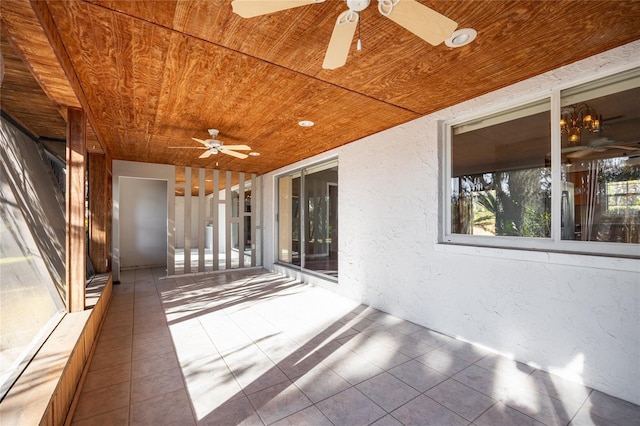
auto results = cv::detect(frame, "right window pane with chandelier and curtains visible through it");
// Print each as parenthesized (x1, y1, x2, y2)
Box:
(560, 70, 640, 243)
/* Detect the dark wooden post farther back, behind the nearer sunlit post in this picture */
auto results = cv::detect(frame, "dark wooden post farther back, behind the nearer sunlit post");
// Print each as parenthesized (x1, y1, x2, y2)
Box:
(89, 154, 111, 274)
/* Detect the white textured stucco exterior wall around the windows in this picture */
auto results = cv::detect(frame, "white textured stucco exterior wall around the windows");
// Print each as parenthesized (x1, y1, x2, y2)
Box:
(263, 42, 640, 404)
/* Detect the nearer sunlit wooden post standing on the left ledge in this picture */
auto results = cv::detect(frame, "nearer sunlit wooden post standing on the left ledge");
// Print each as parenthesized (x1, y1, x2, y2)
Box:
(65, 107, 87, 312)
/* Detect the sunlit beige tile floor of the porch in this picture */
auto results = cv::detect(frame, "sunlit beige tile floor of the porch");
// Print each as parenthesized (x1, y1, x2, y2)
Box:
(73, 269, 640, 426)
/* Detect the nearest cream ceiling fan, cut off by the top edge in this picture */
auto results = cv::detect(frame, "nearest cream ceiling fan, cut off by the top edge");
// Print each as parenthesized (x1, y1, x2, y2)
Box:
(231, 0, 458, 69)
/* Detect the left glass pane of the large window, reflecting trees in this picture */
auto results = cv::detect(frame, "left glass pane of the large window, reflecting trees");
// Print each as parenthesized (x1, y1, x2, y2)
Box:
(450, 100, 551, 238)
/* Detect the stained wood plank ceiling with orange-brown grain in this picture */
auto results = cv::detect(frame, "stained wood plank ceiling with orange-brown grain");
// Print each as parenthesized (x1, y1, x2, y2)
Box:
(0, 0, 640, 174)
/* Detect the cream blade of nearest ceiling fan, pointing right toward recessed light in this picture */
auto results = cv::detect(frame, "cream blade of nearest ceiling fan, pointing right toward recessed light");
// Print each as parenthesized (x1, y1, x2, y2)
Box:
(379, 0, 458, 46)
